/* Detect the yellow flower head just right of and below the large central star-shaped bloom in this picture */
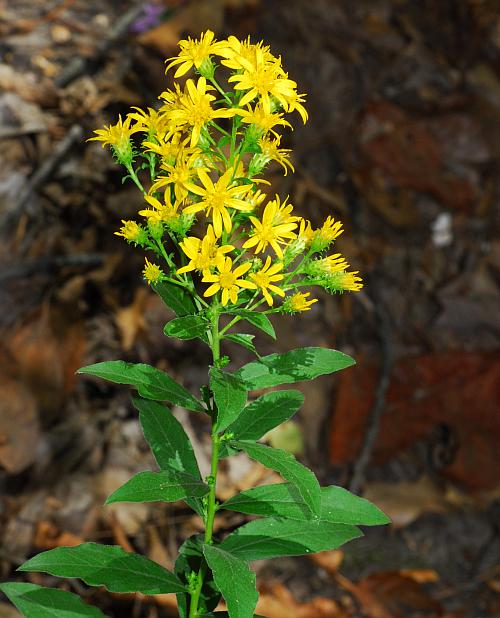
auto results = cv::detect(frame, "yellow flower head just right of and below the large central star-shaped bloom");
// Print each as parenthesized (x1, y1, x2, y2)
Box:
(243, 195, 299, 258)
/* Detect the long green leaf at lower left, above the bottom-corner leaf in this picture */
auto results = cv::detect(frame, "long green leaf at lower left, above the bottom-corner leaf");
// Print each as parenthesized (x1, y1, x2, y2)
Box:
(18, 543, 185, 594)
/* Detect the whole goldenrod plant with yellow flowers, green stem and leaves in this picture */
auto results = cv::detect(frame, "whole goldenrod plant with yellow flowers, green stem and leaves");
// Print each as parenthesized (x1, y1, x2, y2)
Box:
(1, 31, 388, 618)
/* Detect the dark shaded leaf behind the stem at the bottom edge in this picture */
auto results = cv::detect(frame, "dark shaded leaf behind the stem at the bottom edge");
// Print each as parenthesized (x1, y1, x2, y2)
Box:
(174, 534, 221, 618)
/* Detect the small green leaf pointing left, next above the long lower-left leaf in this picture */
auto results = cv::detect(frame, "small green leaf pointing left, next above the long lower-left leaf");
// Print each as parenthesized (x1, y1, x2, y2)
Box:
(106, 470, 209, 504)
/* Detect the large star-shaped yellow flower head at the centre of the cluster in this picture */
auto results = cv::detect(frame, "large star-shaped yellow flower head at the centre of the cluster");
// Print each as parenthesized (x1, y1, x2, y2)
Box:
(184, 167, 251, 237)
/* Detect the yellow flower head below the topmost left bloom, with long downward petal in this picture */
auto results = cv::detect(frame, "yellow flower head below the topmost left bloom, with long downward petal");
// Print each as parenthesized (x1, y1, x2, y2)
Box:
(167, 77, 234, 146)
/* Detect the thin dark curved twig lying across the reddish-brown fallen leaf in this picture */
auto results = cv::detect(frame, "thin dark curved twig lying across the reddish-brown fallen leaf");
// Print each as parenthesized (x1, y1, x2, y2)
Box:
(349, 279, 394, 493)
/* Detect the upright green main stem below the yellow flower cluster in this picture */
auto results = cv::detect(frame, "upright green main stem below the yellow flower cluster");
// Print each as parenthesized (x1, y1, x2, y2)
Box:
(189, 307, 220, 618)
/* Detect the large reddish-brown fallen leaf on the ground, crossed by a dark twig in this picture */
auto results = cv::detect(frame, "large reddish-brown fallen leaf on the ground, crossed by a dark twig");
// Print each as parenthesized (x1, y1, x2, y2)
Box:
(330, 352, 500, 491)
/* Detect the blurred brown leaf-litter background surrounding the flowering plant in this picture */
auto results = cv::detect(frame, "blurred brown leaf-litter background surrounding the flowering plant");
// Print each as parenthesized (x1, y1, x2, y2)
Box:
(0, 0, 500, 618)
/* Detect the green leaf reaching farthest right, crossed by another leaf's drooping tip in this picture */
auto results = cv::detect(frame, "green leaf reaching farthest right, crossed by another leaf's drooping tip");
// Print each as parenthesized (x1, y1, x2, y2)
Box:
(220, 483, 390, 526)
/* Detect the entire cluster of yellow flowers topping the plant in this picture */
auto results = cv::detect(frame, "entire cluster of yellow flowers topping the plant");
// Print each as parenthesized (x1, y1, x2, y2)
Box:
(91, 31, 362, 313)
